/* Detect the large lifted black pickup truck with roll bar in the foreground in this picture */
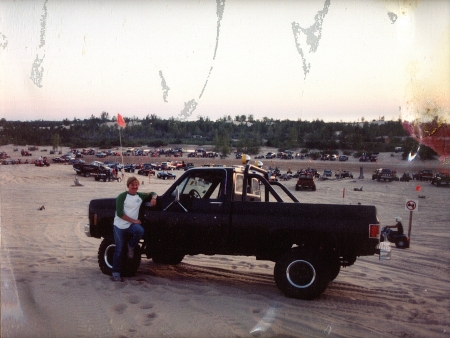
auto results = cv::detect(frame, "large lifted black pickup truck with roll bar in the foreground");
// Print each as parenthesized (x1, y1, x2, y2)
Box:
(85, 165, 380, 299)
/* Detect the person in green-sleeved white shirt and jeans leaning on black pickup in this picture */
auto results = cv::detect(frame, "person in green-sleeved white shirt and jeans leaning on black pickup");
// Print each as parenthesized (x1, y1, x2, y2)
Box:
(111, 176, 157, 282)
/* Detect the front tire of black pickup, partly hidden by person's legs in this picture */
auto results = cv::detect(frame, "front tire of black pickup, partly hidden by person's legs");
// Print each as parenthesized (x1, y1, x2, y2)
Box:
(98, 236, 141, 277)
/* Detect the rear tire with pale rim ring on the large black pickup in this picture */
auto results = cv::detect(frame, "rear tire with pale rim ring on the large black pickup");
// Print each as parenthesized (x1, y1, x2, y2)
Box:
(274, 248, 331, 300)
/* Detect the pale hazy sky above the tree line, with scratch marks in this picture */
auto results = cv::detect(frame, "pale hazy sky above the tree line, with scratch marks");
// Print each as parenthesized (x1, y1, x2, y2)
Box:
(0, 0, 450, 122)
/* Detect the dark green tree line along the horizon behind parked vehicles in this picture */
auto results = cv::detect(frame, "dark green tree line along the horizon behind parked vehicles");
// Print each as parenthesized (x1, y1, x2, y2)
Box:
(0, 112, 435, 158)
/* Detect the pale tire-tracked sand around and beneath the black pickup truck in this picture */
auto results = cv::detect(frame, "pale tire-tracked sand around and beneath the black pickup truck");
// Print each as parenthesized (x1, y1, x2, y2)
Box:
(0, 146, 450, 338)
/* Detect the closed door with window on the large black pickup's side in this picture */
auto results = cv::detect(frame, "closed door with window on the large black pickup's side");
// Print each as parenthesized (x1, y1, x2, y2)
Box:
(157, 169, 230, 253)
